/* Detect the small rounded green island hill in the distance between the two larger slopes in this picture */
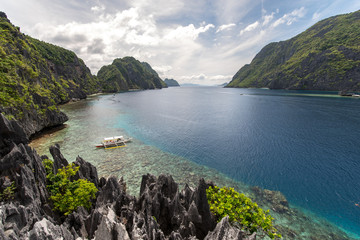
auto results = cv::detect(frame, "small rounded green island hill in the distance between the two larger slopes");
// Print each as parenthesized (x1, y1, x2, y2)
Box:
(97, 57, 166, 92)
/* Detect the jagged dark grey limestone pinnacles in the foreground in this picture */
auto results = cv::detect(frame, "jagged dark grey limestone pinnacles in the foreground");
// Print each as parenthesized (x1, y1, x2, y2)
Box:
(0, 114, 255, 240)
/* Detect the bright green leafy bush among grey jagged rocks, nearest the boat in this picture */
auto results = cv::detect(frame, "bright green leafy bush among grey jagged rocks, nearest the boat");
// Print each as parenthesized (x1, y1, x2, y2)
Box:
(43, 159, 98, 215)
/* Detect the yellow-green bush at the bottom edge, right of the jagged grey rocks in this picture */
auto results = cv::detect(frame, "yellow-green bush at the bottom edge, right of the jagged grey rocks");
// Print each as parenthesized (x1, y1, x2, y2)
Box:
(206, 186, 281, 239)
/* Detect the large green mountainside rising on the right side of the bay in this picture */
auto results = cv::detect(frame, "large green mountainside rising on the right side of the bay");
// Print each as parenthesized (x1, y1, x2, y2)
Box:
(227, 11, 360, 91)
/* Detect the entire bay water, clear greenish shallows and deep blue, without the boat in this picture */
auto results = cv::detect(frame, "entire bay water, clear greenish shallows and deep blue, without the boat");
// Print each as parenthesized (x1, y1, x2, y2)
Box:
(34, 87, 360, 239)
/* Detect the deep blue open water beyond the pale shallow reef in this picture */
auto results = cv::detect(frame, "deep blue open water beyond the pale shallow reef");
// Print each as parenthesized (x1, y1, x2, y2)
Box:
(111, 87, 360, 236)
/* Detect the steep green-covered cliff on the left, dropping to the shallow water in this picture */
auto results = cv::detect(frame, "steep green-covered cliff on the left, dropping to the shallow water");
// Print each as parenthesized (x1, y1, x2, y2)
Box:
(0, 12, 101, 137)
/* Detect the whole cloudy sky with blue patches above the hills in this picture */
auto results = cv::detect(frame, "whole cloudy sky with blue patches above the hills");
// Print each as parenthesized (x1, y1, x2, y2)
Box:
(0, 0, 360, 85)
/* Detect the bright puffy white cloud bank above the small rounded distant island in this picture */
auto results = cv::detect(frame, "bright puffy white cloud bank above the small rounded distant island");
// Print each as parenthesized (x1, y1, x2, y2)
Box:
(33, 7, 215, 73)
